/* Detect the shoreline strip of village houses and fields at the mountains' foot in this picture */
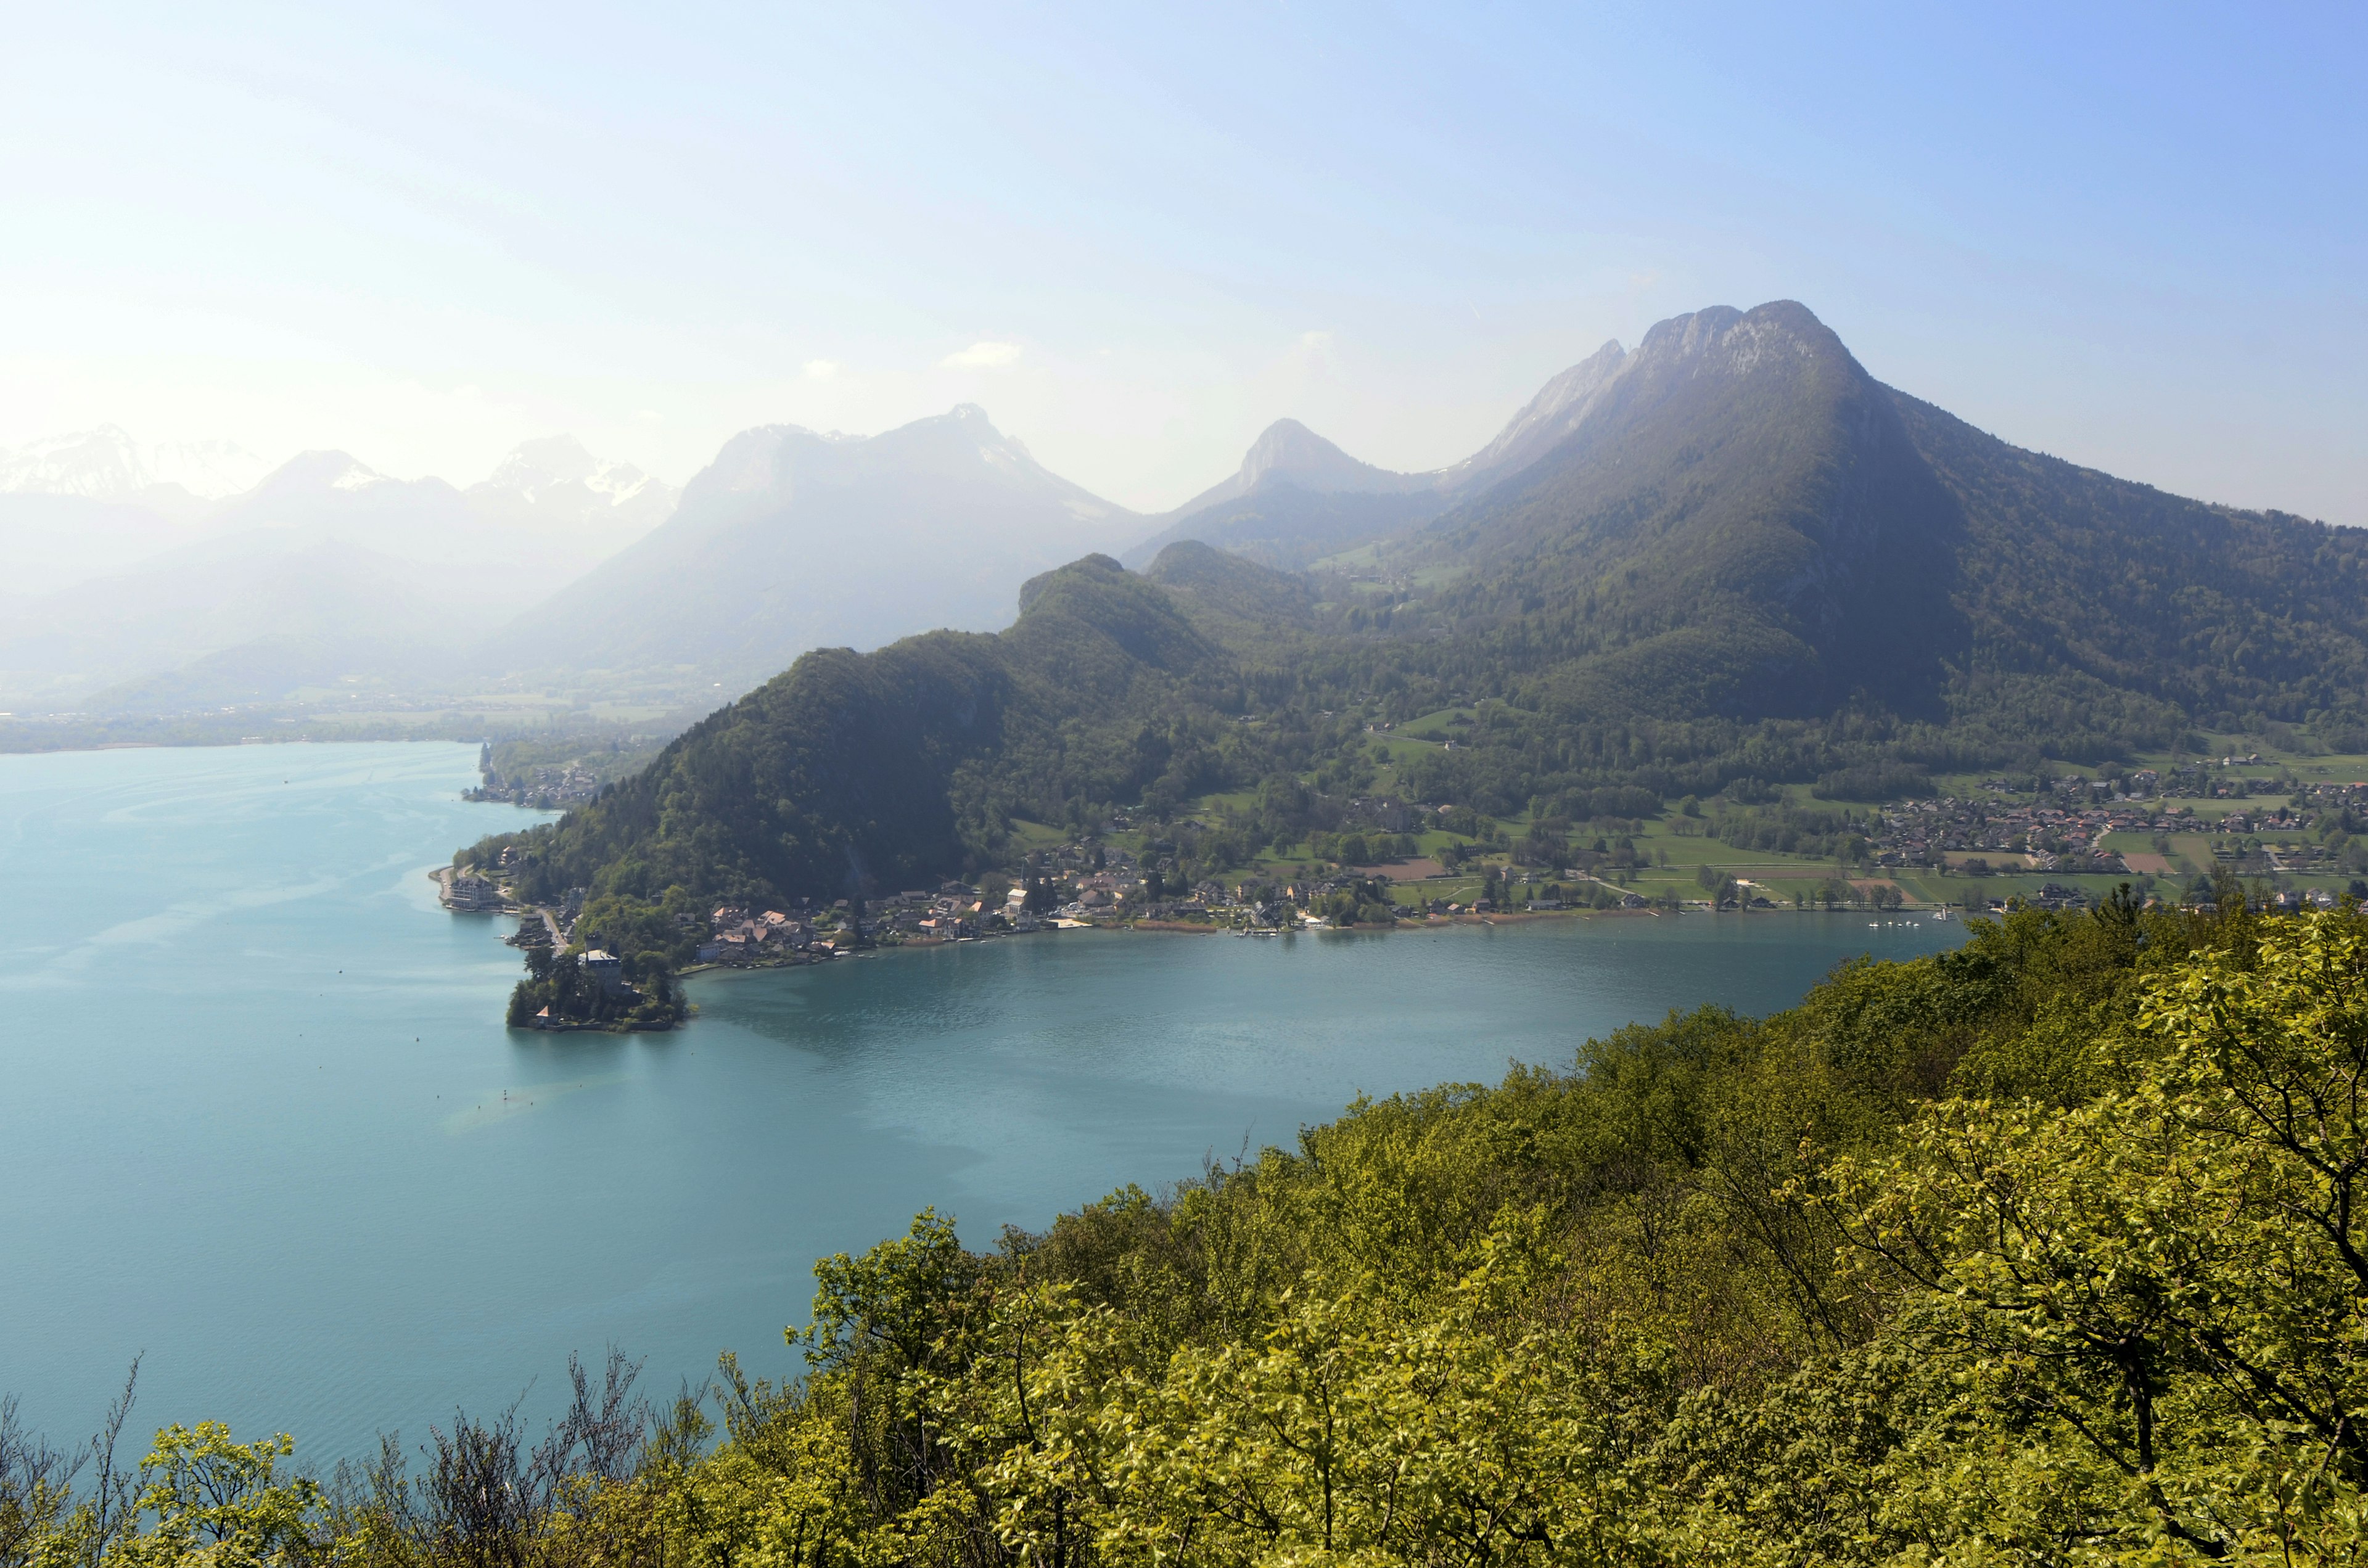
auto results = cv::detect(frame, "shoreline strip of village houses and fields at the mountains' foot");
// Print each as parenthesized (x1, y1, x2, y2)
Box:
(438, 755, 2368, 1028)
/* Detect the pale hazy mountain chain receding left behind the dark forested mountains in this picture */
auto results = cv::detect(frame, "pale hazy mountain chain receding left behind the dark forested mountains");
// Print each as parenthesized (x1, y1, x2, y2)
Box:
(0, 346, 1761, 713)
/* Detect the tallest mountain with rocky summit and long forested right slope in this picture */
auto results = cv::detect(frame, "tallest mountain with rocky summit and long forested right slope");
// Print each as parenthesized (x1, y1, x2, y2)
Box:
(1297, 301, 2368, 751)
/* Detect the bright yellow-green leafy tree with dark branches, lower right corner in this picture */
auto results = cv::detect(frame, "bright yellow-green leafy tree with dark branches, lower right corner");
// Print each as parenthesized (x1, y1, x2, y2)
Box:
(1838, 917, 2368, 1561)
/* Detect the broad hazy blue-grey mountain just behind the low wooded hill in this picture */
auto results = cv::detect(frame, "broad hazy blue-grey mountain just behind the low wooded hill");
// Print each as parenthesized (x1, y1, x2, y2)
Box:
(479, 405, 1139, 678)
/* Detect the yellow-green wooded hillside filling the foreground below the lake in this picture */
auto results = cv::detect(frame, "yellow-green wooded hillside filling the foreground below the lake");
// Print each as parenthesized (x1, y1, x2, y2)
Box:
(18, 893, 2368, 1568)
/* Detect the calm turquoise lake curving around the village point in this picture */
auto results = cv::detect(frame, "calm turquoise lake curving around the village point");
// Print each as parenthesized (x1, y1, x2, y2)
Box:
(0, 744, 1963, 1461)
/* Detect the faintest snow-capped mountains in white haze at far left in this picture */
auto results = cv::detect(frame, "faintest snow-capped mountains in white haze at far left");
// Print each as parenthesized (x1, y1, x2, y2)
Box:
(0, 431, 677, 706)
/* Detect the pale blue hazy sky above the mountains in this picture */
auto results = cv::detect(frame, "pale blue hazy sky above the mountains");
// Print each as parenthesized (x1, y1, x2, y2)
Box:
(0, 0, 2368, 523)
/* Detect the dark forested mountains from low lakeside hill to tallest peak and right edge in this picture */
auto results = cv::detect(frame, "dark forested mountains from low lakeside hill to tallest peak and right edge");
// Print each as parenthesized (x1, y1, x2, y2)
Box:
(509, 301, 2368, 914)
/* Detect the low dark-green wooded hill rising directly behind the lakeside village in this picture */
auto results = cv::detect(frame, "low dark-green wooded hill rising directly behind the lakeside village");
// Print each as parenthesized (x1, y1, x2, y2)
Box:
(525, 557, 1241, 898)
